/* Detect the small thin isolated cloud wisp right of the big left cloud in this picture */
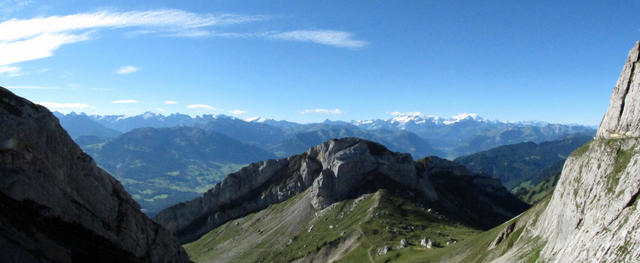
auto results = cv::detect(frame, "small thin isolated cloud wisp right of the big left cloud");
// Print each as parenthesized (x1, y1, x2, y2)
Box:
(266, 30, 368, 48)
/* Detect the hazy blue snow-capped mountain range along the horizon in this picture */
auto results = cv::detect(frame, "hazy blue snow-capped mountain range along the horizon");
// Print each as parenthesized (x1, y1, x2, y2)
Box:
(56, 112, 595, 159)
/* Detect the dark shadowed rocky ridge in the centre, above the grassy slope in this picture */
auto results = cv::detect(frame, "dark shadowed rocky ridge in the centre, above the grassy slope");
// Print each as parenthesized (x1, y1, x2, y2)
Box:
(155, 138, 527, 242)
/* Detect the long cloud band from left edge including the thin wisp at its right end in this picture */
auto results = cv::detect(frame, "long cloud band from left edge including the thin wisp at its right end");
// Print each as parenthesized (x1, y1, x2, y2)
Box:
(0, 9, 368, 65)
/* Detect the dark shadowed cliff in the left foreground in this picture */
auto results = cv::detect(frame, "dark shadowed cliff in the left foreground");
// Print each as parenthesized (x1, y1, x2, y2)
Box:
(0, 87, 189, 262)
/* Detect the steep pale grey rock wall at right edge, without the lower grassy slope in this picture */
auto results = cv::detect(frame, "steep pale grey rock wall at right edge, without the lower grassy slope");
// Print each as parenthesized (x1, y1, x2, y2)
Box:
(534, 42, 640, 262)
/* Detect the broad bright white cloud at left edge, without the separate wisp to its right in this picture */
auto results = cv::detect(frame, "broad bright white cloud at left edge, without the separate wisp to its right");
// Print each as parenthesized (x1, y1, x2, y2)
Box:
(0, 9, 266, 65)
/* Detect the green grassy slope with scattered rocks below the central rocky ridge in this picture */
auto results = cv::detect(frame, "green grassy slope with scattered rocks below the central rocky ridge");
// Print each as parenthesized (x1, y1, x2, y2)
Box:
(185, 190, 480, 262)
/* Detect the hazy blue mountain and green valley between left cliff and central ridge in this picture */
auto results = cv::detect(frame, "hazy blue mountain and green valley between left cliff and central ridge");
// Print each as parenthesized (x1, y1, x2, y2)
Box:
(82, 127, 275, 215)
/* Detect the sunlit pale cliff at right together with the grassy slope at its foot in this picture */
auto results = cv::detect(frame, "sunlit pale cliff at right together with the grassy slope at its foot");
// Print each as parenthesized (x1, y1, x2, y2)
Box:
(441, 42, 640, 262)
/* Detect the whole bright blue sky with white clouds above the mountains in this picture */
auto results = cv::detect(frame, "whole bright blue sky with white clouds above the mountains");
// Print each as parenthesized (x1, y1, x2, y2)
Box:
(0, 1, 640, 125)
